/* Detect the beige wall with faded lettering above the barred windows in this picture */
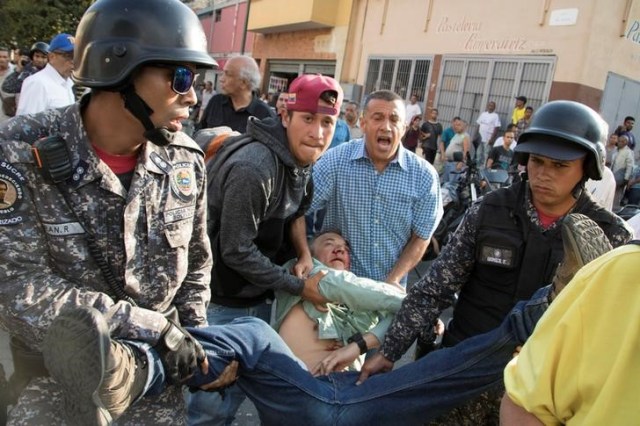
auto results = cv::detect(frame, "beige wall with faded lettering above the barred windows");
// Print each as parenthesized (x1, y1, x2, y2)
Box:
(341, 0, 640, 90)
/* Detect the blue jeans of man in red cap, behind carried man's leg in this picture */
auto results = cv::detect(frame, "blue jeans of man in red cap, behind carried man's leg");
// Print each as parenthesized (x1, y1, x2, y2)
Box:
(184, 303, 271, 426)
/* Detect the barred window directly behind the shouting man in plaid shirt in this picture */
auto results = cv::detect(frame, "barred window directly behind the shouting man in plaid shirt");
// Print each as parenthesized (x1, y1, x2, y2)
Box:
(364, 57, 431, 102)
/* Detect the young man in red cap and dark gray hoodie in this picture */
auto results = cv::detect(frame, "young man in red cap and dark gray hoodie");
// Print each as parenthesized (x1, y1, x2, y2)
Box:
(189, 75, 343, 425)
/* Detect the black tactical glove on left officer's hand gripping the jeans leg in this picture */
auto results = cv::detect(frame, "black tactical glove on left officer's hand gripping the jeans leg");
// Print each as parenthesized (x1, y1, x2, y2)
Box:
(156, 319, 206, 385)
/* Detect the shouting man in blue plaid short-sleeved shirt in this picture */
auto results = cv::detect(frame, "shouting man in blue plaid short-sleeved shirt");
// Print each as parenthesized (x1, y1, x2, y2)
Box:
(311, 90, 442, 285)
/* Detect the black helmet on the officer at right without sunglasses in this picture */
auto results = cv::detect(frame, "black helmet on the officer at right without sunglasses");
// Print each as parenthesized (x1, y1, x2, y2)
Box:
(515, 101, 608, 180)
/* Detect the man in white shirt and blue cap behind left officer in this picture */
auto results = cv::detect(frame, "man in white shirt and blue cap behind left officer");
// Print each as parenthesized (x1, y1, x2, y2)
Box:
(17, 33, 75, 115)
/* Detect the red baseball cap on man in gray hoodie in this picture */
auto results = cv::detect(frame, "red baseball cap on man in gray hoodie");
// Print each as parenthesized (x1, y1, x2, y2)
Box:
(286, 74, 344, 115)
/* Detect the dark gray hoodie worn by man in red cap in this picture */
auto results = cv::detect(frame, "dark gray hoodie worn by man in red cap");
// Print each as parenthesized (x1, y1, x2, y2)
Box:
(207, 117, 312, 307)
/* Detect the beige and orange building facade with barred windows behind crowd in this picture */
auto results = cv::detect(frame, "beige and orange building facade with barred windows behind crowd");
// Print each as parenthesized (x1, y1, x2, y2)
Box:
(242, 0, 640, 133)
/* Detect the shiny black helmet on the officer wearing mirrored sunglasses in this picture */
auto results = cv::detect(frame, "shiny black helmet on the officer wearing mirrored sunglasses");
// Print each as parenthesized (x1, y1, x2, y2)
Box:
(73, 0, 217, 89)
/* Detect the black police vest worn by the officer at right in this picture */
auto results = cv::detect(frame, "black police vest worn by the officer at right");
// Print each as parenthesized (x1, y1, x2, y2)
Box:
(446, 182, 615, 345)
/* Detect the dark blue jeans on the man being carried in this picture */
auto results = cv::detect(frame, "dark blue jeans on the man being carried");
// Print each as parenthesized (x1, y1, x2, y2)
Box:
(169, 286, 550, 425)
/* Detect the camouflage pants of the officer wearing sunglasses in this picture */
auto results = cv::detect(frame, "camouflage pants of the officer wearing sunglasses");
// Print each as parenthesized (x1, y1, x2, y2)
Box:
(7, 378, 186, 426)
